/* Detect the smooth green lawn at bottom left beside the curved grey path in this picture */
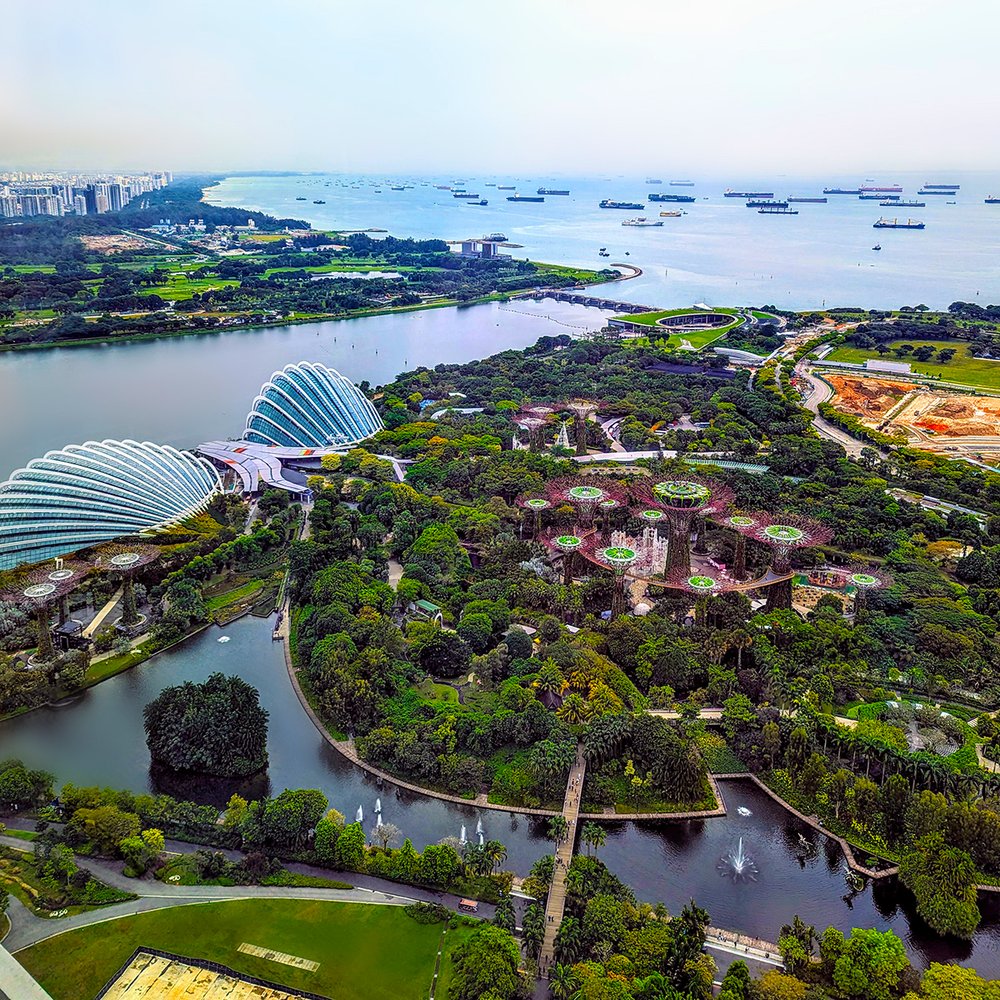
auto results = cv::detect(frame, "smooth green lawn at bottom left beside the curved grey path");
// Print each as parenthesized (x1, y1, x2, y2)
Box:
(17, 899, 470, 1000)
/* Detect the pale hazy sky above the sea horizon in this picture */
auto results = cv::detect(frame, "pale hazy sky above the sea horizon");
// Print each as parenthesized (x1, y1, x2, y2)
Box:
(0, 0, 1000, 176)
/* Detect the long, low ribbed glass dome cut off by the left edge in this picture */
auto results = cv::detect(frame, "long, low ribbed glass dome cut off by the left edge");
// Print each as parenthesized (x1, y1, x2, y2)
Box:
(0, 440, 220, 570)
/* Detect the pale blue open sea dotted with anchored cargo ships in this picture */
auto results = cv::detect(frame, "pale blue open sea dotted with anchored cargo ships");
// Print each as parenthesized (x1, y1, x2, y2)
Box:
(208, 172, 1000, 309)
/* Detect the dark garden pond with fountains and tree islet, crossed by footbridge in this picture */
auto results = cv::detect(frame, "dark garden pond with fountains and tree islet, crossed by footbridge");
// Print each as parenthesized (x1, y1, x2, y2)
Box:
(0, 618, 1000, 975)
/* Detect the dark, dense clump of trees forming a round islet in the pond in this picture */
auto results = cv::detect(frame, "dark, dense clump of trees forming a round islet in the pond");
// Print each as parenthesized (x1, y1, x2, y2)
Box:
(143, 673, 267, 778)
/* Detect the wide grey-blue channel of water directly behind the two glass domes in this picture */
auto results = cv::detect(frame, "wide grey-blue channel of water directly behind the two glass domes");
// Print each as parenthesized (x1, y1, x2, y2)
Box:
(0, 300, 607, 480)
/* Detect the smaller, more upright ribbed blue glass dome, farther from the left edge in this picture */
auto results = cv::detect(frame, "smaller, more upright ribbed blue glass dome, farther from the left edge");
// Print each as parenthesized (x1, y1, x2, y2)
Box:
(243, 361, 382, 448)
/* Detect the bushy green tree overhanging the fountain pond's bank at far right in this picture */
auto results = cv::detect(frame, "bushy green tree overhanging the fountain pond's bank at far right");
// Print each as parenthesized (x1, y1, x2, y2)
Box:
(899, 833, 980, 939)
